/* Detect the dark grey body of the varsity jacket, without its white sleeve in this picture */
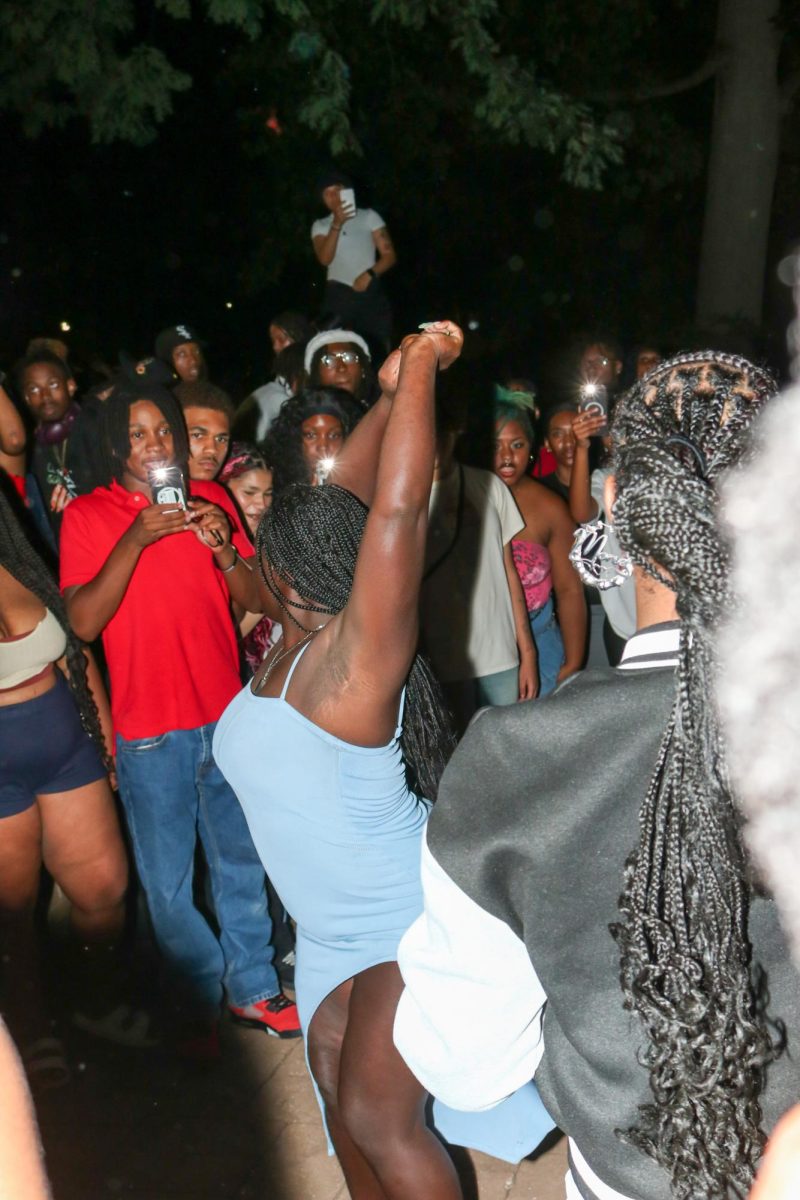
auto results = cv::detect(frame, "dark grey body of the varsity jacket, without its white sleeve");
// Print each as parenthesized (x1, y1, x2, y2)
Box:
(428, 668, 800, 1200)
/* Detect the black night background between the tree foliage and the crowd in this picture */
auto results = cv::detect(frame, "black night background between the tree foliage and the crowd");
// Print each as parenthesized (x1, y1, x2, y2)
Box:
(0, 2, 800, 398)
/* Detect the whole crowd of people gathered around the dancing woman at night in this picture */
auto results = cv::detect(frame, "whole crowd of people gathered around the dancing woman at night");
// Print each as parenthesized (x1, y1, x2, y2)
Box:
(0, 176, 800, 1200)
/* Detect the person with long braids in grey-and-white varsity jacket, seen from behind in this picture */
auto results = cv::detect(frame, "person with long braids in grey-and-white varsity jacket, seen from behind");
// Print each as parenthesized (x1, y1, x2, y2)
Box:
(395, 352, 786, 1200)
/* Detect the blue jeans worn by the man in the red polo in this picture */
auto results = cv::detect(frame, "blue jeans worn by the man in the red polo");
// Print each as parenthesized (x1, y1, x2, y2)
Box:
(116, 725, 281, 1013)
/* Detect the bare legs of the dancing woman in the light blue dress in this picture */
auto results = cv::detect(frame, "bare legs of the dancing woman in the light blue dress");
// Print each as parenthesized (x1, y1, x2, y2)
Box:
(308, 962, 462, 1200)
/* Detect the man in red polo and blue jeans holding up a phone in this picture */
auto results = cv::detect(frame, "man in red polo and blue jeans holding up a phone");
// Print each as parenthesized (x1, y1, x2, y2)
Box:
(61, 384, 300, 1043)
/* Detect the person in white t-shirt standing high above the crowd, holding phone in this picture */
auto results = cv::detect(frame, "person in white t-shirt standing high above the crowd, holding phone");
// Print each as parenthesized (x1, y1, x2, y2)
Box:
(311, 169, 397, 352)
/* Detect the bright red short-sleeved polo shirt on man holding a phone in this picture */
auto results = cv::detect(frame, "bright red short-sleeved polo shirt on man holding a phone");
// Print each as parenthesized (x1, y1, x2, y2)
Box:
(60, 480, 253, 738)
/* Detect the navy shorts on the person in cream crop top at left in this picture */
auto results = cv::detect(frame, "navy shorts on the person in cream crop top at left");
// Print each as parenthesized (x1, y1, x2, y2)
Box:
(0, 670, 106, 817)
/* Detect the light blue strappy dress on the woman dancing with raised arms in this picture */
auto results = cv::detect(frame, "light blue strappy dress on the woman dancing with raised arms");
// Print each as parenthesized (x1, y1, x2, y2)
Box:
(213, 643, 553, 1162)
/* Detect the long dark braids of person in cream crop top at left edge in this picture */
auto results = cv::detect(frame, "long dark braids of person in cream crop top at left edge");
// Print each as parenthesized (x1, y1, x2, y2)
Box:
(0, 488, 112, 770)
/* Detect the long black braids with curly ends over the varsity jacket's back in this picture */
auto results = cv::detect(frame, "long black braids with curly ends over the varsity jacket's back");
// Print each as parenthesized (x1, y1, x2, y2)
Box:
(612, 352, 776, 1200)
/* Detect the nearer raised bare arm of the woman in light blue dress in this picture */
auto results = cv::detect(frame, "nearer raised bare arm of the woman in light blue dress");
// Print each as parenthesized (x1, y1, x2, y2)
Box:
(339, 322, 463, 695)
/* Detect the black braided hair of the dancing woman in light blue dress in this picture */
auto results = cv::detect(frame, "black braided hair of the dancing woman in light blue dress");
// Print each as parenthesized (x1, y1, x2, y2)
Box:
(255, 484, 456, 800)
